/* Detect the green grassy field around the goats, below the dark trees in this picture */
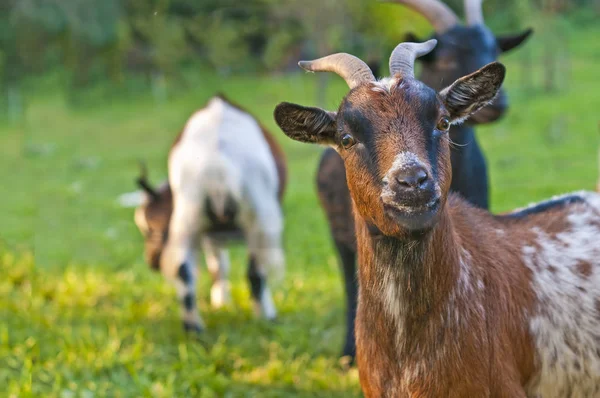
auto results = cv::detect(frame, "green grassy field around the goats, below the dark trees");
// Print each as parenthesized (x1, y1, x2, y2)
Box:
(0, 23, 600, 397)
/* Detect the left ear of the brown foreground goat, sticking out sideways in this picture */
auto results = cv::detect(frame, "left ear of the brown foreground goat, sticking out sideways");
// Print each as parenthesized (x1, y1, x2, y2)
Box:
(274, 102, 337, 145)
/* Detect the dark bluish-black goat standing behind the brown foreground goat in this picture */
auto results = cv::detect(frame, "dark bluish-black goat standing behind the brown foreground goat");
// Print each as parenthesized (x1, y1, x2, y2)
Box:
(317, 0, 532, 358)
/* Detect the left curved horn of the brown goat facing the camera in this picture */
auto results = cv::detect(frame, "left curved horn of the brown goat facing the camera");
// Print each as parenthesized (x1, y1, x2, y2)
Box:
(298, 53, 375, 89)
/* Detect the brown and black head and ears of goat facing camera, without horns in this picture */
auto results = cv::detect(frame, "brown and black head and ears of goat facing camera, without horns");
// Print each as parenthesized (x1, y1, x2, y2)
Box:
(275, 43, 505, 238)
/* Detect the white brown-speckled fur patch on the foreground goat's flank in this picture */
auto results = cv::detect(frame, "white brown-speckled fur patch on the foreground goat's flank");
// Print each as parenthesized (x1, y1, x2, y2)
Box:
(522, 193, 600, 398)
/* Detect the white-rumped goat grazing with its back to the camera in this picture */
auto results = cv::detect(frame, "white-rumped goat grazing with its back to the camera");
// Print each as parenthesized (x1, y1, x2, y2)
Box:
(135, 95, 287, 332)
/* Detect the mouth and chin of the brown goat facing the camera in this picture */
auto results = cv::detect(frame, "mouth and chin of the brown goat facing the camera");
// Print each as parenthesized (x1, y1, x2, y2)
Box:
(383, 197, 440, 231)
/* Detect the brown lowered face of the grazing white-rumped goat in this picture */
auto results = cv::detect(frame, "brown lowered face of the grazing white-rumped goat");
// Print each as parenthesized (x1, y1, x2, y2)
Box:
(135, 184, 173, 271)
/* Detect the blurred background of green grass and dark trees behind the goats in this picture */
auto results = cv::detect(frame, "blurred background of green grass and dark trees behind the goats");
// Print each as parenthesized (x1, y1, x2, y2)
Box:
(0, 0, 600, 397)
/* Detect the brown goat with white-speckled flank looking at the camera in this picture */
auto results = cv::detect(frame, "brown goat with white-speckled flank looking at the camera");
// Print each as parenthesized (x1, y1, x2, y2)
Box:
(274, 40, 600, 398)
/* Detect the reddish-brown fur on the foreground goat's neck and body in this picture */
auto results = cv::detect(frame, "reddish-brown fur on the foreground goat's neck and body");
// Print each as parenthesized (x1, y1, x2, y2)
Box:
(356, 196, 587, 397)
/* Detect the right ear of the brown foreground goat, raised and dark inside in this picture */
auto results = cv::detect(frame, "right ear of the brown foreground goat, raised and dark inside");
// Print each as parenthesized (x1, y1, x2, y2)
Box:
(440, 62, 506, 124)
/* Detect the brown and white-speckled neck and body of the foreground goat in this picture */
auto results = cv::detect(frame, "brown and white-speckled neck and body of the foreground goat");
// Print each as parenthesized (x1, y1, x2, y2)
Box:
(356, 193, 600, 398)
